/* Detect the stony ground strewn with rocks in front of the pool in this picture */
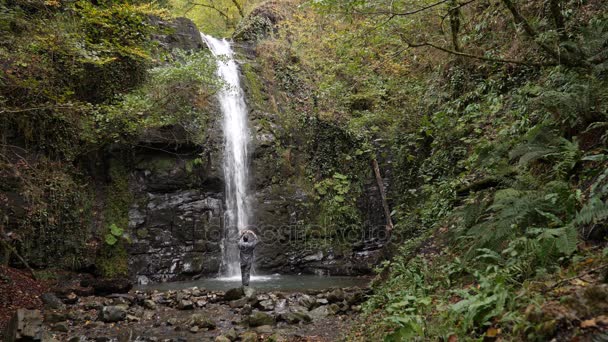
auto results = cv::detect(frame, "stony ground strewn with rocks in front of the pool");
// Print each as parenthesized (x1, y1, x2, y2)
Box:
(4, 272, 367, 342)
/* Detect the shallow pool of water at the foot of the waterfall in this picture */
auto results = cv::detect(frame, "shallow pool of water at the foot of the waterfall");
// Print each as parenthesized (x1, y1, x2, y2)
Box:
(138, 274, 371, 291)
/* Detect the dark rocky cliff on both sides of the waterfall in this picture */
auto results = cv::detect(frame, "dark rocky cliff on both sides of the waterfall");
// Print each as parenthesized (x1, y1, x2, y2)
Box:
(128, 11, 385, 283)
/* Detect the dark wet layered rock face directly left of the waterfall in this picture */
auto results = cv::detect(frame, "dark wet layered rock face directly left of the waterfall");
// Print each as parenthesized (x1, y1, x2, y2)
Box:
(128, 116, 224, 284)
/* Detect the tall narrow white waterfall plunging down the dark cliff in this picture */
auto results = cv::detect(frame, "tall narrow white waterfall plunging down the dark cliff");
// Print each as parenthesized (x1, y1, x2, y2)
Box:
(201, 33, 250, 277)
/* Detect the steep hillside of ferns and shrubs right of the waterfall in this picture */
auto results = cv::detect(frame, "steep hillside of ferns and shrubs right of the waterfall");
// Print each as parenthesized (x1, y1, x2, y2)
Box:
(228, 1, 608, 341)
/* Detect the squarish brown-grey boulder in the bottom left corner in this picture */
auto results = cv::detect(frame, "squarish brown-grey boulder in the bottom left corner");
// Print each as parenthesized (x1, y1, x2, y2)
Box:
(4, 309, 42, 342)
